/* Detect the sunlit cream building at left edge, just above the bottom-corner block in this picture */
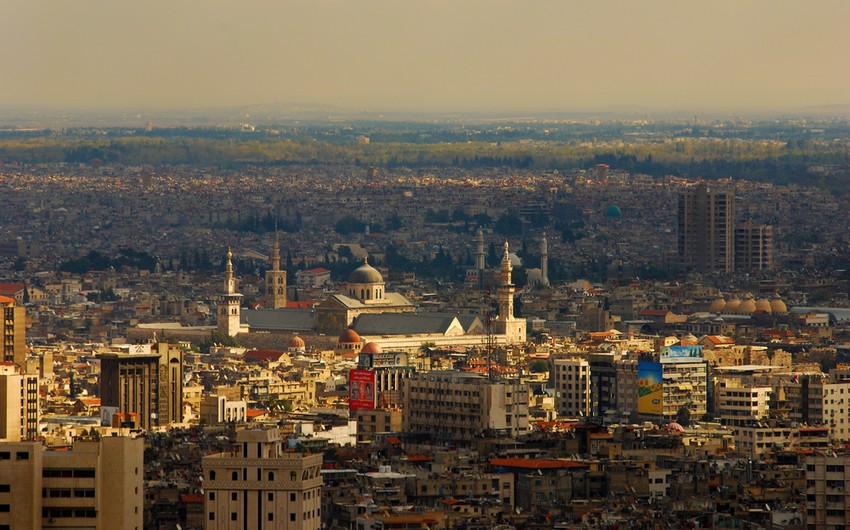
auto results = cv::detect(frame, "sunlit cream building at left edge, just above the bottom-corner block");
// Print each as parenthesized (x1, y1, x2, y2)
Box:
(0, 361, 39, 442)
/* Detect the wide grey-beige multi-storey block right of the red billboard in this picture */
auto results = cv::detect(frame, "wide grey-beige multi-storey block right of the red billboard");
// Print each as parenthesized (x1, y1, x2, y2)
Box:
(402, 371, 528, 444)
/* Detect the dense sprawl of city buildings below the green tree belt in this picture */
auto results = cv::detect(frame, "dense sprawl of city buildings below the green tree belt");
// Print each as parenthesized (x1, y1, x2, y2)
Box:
(0, 115, 850, 529)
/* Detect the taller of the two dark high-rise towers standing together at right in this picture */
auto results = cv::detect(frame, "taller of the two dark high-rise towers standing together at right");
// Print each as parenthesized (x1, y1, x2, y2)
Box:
(678, 185, 735, 272)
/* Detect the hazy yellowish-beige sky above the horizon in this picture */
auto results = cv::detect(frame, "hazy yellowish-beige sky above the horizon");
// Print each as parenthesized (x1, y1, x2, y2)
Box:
(0, 0, 850, 112)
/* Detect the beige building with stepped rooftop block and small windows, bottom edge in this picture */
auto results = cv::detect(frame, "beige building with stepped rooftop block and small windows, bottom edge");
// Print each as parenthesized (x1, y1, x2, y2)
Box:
(202, 429, 322, 530)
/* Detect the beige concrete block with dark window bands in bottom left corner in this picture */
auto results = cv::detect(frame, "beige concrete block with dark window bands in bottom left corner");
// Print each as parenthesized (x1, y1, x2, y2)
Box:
(0, 436, 144, 530)
